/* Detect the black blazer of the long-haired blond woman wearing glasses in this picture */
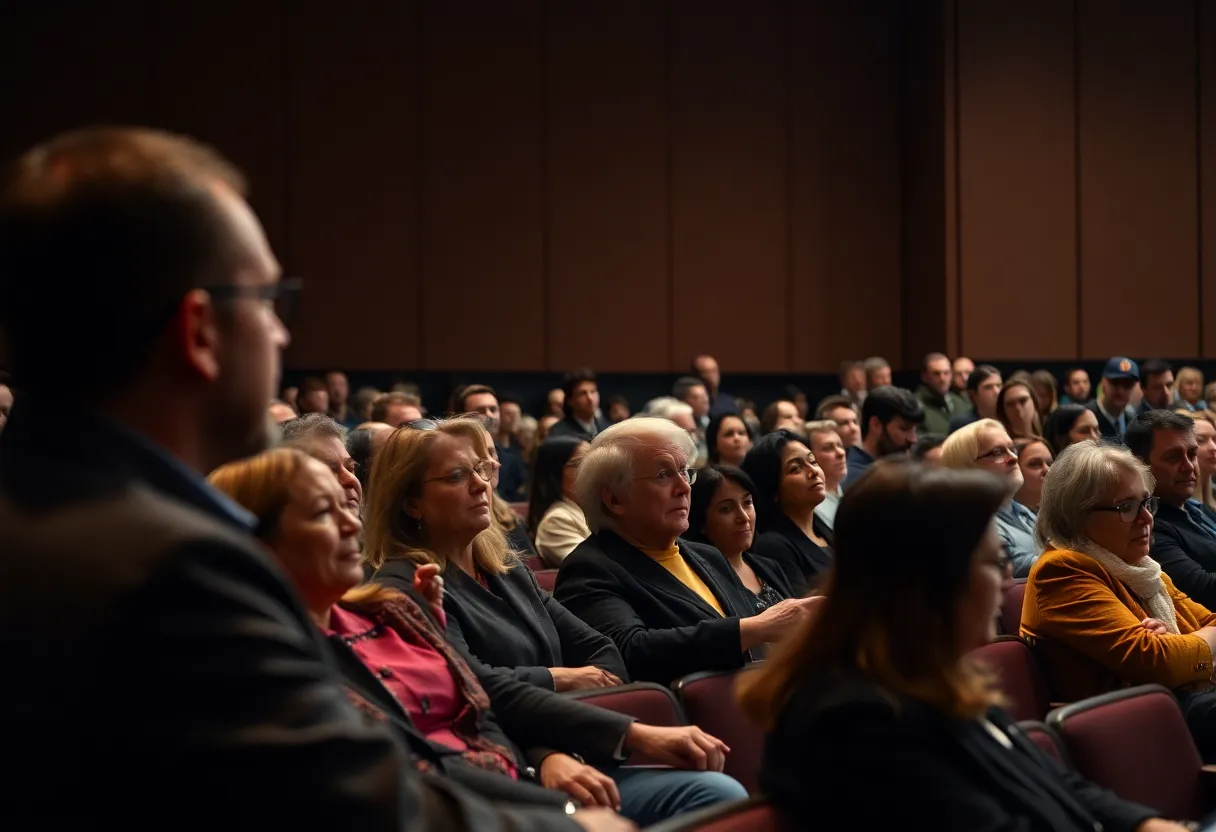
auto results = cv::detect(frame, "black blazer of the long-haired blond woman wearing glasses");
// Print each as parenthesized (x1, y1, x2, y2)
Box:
(376, 558, 629, 691)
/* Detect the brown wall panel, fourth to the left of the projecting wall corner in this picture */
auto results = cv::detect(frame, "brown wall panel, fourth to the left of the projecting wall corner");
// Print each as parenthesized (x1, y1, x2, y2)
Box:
(420, 0, 545, 370)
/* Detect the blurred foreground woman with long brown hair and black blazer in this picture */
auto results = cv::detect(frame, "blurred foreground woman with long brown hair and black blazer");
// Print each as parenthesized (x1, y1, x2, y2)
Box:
(741, 461, 1184, 832)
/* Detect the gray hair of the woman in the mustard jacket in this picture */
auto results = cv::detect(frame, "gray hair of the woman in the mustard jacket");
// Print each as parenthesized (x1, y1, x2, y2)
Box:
(1035, 442, 1156, 549)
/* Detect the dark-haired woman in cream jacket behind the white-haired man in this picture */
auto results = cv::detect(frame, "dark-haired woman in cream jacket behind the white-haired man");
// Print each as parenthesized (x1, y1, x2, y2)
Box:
(528, 437, 591, 569)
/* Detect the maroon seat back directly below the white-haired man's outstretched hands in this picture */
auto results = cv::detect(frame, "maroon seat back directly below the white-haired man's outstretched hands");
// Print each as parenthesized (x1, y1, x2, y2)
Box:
(671, 670, 764, 794)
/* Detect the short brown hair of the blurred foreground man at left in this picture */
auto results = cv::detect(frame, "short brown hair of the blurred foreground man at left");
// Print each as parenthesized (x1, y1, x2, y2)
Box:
(0, 128, 244, 395)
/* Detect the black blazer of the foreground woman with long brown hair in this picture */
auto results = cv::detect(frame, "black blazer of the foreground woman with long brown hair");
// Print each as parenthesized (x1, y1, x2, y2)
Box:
(760, 676, 1158, 832)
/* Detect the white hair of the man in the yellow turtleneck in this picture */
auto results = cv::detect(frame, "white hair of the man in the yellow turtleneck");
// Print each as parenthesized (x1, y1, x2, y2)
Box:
(574, 416, 697, 532)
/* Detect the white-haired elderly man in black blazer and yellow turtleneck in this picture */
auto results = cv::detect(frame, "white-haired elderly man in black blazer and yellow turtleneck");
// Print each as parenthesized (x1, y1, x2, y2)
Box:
(554, 417, 818, 685)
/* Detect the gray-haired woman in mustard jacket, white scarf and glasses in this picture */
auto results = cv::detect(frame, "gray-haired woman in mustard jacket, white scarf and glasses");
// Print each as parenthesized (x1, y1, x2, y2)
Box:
(1021, 442, 1216, 761)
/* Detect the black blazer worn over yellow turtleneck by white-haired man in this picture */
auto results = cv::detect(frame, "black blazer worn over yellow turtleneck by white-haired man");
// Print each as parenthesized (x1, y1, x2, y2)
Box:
(553, 530, 755, 685)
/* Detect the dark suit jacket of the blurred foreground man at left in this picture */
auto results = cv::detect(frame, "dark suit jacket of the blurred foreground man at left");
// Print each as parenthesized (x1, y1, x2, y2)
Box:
(0, 395, 575, 832)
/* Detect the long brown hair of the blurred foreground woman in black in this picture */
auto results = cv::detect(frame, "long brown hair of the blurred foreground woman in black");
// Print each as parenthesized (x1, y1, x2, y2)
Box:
(739, 460, 1006, 730)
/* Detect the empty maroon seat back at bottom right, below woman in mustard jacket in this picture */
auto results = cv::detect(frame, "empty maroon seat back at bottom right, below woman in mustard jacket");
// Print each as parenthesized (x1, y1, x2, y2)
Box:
(1047, 685, 1209, 819)
